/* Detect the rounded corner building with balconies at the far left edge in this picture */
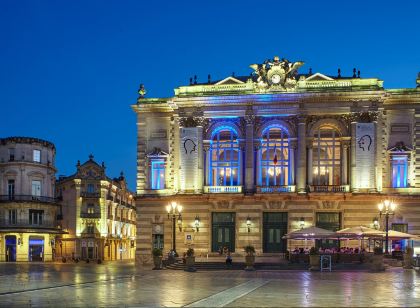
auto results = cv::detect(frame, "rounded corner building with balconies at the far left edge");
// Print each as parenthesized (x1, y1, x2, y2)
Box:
(0, 137, 63, 262)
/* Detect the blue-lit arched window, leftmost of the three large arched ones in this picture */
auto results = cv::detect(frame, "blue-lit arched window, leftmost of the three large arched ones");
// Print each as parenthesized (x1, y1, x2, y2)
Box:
(208, 128, 241, 186)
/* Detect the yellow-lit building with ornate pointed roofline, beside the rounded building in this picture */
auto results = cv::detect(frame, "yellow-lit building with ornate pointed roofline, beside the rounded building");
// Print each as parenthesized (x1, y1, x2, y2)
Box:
(56, 155, 136, 260)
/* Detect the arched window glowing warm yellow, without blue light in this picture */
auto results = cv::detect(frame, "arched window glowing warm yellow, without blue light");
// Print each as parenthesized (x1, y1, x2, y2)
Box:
(312, 127, 341, 185)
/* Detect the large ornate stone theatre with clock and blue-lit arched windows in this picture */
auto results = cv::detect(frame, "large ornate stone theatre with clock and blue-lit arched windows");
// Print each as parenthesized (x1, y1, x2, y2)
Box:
(132, 57, 420, 262)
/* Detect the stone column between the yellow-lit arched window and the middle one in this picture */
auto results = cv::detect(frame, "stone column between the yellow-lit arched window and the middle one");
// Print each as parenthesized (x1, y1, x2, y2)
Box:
(296, 116, 306, 193)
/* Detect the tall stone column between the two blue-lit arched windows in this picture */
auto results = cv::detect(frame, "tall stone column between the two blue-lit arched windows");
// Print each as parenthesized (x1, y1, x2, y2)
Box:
(243, 115, 256, 193)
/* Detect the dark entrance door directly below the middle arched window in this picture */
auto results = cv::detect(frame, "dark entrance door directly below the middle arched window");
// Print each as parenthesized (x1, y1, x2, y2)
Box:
(263, 213, 287, 252)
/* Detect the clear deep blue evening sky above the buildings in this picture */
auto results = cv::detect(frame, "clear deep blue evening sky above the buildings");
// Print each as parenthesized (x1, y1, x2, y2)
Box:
(0, 0, 420, 189)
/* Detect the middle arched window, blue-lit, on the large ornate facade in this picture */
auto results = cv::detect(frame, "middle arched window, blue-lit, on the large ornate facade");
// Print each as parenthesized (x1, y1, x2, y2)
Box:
(259, 127, 290, 186)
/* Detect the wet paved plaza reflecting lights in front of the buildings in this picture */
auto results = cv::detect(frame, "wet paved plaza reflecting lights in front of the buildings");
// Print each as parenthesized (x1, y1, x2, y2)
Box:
(0, 262, 420, 307)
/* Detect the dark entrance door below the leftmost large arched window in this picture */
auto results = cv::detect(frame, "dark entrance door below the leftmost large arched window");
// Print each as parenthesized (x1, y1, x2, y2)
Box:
(211, 213, 235, 252)
